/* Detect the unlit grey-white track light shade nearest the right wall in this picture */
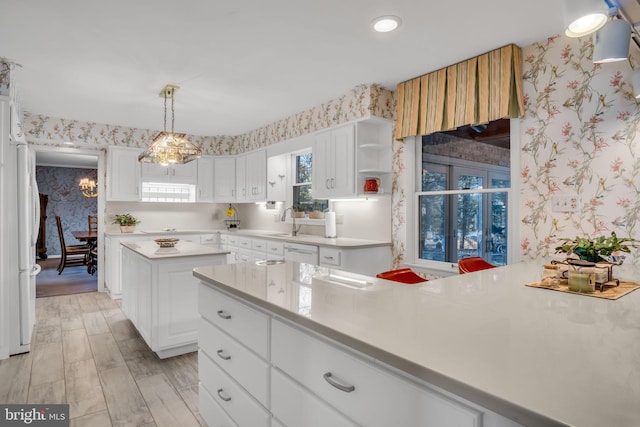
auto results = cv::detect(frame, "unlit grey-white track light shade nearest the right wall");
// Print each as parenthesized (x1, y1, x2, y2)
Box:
(593, 19, 631, 64)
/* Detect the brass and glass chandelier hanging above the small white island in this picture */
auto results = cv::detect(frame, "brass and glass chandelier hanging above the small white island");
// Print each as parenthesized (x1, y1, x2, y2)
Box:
(138, 85, 202, 166)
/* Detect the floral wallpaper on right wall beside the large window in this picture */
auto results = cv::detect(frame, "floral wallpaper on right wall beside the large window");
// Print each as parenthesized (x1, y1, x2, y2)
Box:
(520, 36, 640, 263)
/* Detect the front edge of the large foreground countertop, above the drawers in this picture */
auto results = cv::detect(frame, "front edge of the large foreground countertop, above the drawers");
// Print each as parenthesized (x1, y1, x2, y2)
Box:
(193, 269, 568, 427)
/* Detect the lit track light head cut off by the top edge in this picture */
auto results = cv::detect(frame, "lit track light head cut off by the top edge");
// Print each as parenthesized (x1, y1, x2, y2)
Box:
(564, 0, 609, 37)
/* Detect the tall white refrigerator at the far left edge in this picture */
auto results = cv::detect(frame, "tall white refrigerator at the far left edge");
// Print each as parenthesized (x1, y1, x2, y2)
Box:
(0, 97, 40, 359)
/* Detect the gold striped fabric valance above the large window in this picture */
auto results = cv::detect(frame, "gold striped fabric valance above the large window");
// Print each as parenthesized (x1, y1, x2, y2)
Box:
(395, 44, 524, 139)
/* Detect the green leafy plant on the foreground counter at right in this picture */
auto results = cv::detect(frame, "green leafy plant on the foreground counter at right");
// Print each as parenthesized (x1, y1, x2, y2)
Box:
(556, 232, 638, 262)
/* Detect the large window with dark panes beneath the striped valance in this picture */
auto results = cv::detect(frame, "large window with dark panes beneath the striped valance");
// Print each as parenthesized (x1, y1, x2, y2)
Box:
(416, 118, 510, 265)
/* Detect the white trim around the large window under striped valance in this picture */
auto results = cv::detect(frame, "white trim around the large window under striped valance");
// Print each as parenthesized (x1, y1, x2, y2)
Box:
(404, 119, 522, 276)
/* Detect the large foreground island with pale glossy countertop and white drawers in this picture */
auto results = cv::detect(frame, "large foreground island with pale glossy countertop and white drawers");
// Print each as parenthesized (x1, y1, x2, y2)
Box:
(194, 262, 640, 427)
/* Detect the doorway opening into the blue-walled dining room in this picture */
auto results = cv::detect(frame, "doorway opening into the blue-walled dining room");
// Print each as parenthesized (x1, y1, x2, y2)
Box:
(30, 146, 104, 298)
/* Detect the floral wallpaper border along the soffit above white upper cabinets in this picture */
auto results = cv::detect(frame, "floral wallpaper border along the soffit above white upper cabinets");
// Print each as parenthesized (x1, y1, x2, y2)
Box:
(24, 85, 395, 155)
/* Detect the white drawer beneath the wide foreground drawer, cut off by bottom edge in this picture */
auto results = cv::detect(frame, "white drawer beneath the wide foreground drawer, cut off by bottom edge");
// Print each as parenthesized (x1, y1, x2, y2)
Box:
(271, 369, 356, 427)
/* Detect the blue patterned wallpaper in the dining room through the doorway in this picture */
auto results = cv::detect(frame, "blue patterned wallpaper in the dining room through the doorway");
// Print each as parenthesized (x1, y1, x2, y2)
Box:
(36, 166, 98, 256)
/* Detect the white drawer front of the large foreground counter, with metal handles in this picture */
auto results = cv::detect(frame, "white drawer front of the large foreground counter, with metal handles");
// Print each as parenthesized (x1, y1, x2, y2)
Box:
(198, 283, 515, 427)
